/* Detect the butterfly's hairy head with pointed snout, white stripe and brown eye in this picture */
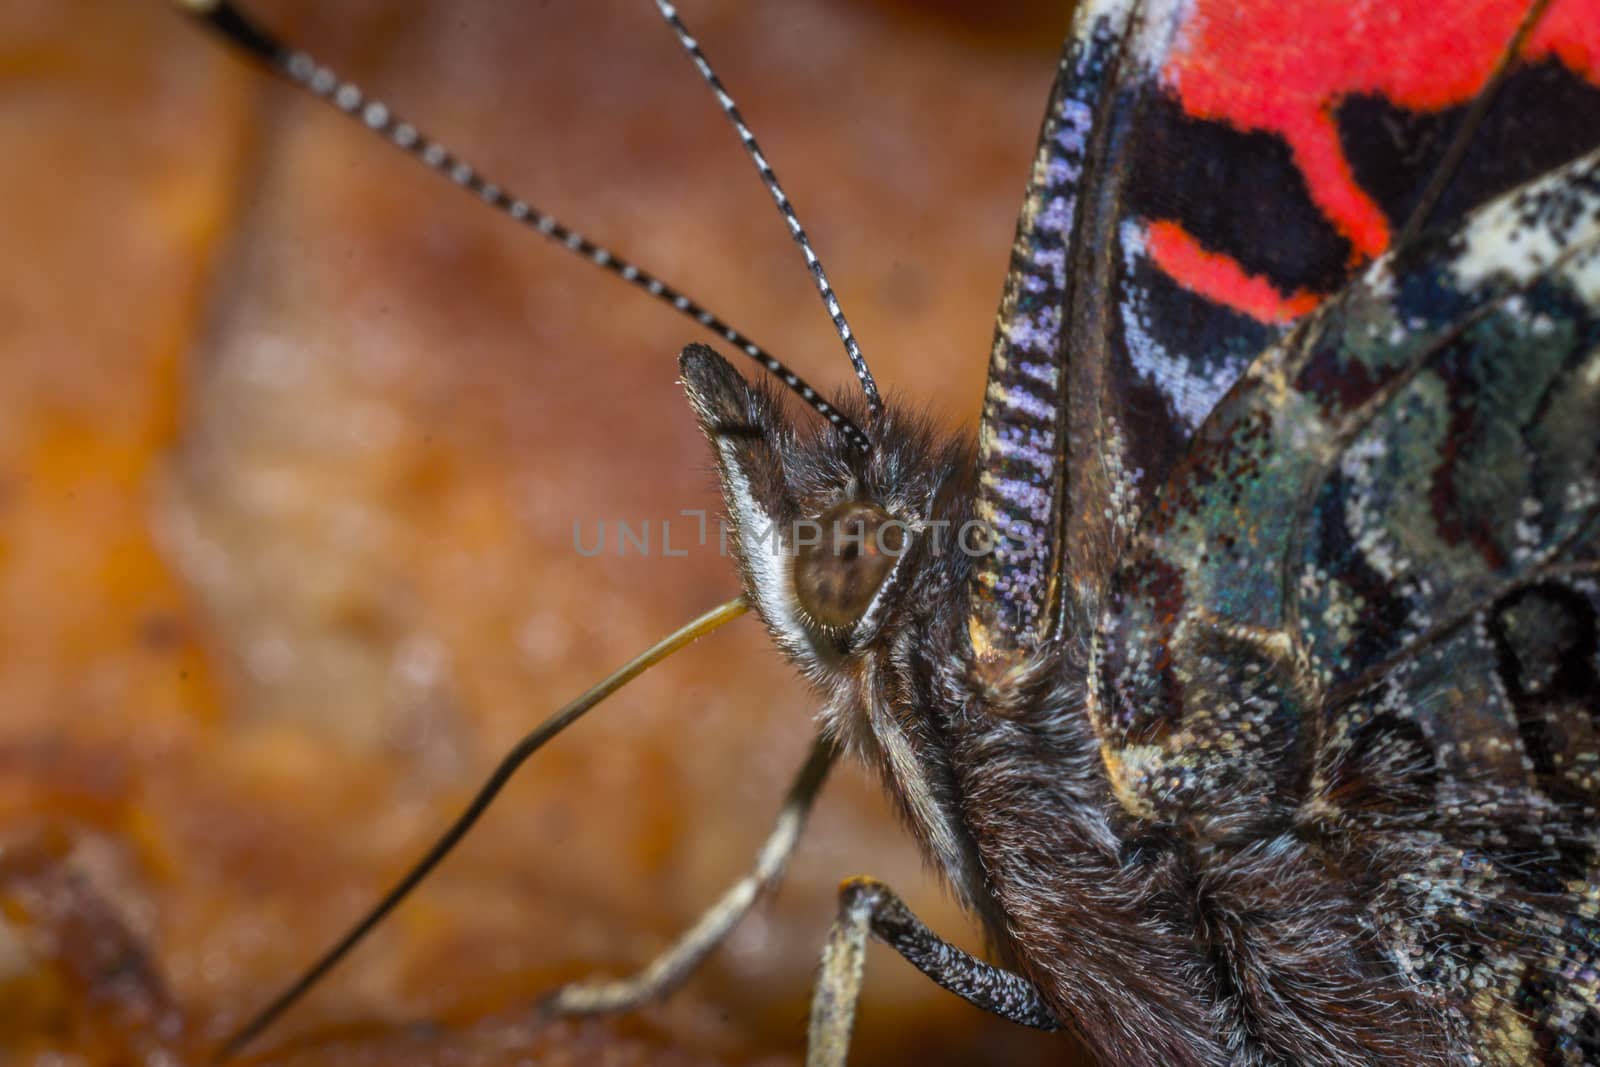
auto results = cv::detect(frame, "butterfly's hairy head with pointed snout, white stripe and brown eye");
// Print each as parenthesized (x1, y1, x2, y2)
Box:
(680, 344, 971, 680)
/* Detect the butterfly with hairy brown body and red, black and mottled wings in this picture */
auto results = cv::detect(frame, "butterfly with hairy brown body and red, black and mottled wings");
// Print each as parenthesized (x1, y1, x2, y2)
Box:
(15, 0, 1600, 1064)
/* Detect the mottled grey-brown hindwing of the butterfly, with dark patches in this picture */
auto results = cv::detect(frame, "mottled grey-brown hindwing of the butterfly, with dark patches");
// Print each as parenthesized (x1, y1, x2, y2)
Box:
(1090, 152, 1600, 1064)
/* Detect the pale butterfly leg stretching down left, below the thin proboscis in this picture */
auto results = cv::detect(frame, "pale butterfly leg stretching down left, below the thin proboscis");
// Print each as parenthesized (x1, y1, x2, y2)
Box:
(542, 737, 838, 1016)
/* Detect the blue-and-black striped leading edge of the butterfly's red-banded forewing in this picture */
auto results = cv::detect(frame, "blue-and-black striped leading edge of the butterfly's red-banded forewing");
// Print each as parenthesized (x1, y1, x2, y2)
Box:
(968, 0, 1196, 657)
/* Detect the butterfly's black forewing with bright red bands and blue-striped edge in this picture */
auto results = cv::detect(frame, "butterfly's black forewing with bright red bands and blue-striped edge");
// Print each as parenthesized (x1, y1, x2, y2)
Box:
(968, 0, 1600, 656)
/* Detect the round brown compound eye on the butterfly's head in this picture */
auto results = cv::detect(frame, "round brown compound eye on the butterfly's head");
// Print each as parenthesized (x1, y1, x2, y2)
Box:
(795, 501, 906, 630)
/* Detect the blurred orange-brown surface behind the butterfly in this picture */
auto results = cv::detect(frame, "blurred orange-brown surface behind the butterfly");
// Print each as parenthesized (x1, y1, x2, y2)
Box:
(0, 0, 1070, 1067)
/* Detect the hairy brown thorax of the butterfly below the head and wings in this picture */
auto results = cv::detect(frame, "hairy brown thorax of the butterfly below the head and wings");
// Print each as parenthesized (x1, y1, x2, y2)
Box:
(857, 601, 1454, 1065)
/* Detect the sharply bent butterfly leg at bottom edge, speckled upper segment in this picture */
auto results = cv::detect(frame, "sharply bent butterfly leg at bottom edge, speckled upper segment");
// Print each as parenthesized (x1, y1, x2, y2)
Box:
(805, 878, 1061, 1067)
